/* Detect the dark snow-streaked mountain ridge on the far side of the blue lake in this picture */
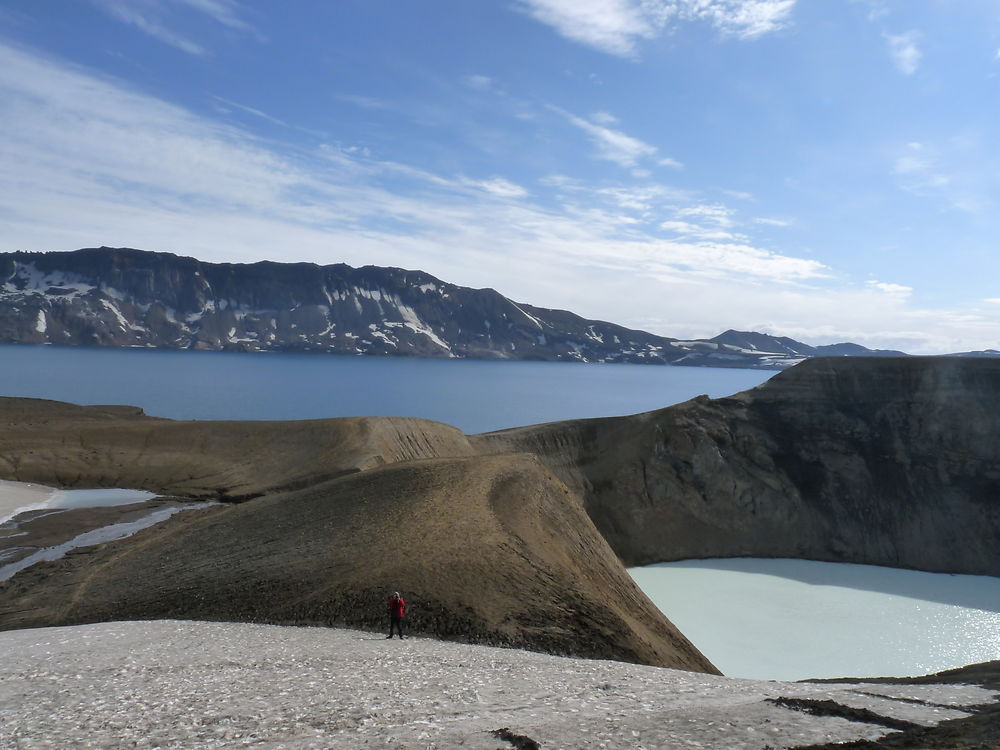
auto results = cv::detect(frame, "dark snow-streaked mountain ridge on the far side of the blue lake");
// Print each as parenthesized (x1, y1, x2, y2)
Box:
(0, 247, 916, 369)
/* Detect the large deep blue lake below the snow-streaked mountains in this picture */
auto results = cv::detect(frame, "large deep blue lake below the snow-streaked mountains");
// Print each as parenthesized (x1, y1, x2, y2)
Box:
(0, 344, 774, 433)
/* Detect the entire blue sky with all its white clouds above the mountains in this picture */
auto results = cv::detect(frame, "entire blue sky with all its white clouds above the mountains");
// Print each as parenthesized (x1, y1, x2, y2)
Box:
(0, 0, 1000, 354)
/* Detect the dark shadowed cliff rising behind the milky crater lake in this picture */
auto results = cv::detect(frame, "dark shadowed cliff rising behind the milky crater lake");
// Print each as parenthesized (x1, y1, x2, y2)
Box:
(476, 358, 1000, 575)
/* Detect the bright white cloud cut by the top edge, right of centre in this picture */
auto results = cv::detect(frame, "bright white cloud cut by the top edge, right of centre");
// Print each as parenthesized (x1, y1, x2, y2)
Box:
(520, 0, 796, 56)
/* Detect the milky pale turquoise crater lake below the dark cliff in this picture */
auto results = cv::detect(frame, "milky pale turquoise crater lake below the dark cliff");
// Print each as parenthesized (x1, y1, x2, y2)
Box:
(629, 558, 1000, 680)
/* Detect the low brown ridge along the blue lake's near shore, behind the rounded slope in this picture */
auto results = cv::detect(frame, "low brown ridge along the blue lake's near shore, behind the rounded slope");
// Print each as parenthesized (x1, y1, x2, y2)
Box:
(0, 398, 472, 499)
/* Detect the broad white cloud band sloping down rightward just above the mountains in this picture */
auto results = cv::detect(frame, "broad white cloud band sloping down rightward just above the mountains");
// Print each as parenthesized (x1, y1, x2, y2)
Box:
(0, 44, 1000, 351)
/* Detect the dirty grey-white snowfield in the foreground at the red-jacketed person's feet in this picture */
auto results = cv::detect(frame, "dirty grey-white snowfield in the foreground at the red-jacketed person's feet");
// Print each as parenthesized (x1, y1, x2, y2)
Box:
(0, 621, 994, 750)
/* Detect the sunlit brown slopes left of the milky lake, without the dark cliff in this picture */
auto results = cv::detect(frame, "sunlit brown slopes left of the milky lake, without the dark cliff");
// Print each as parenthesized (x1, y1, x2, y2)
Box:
(0, 399, 717, 672)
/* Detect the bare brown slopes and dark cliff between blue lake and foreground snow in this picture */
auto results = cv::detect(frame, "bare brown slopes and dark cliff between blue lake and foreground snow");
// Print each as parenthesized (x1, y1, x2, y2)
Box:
(0, 358, 1000, 671)
